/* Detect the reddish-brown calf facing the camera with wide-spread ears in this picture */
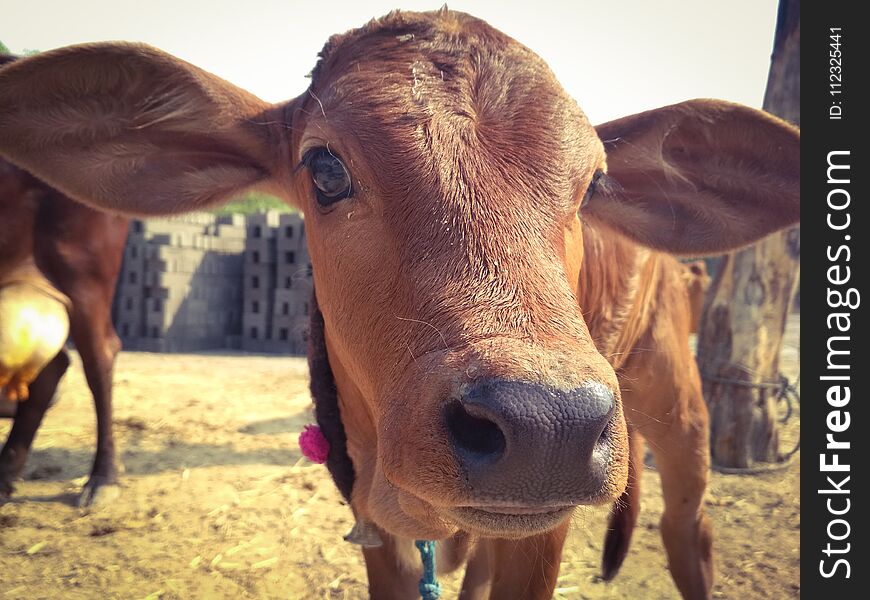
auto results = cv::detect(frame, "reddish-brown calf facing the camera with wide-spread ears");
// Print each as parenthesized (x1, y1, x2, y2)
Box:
(0, 10, 800, 599)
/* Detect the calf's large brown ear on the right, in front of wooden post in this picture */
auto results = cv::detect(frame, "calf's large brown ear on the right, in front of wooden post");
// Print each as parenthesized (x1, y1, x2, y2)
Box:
(582, 100, 800, 255)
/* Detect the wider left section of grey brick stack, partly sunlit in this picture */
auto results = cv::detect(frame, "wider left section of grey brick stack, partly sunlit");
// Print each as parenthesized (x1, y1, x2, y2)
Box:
(115, 213, 246, 352)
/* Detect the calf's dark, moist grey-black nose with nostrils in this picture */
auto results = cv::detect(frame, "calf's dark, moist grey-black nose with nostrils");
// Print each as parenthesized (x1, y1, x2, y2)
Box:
(447, 380, 616, 506)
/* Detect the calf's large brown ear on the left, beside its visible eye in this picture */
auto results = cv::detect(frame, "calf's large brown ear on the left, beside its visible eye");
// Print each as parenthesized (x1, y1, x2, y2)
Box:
(0, 43, 290, 215)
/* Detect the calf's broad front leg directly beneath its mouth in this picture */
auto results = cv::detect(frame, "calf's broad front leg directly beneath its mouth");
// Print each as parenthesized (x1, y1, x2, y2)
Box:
(489, 520, 570, 600)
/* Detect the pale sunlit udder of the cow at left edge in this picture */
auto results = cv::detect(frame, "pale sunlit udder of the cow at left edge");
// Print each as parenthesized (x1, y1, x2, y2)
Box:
(0, 270, 69, 401)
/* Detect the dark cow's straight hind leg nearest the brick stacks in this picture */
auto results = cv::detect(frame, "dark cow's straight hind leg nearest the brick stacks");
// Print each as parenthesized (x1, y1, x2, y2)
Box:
(70, 296, 121, 507)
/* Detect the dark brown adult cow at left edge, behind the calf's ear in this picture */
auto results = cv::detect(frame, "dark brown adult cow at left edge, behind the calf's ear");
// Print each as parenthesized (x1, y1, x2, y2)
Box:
(0, 132, 127, 506)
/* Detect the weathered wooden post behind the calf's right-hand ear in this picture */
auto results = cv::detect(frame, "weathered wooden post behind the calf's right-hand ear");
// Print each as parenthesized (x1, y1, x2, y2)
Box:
(698, 0, 800, 468)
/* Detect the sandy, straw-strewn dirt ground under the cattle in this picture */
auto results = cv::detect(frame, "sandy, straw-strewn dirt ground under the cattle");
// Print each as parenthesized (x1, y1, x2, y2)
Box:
(0, 318, 800, 600)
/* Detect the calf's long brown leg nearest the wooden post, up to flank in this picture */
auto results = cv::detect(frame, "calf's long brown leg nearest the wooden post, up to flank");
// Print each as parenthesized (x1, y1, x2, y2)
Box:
(620, 263, 713, 600)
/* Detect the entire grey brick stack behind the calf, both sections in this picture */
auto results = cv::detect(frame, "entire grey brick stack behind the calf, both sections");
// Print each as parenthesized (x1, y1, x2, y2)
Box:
(115, 211, 311, 354)
